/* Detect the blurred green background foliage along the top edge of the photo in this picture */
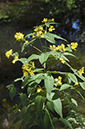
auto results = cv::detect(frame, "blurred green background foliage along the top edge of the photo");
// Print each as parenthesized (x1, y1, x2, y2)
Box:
(0, 0, 84, 22)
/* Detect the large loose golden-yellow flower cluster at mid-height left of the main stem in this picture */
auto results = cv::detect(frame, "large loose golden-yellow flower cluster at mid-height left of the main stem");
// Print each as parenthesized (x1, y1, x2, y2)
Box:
(22, 61, 35, 77)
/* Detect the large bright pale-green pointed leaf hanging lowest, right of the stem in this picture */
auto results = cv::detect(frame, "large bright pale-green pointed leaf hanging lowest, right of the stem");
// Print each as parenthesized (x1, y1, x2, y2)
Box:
(53, 98, 63, 117)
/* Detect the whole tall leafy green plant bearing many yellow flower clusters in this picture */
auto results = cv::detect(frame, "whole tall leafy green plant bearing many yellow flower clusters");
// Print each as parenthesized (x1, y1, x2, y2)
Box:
(5, 18, 85, 129)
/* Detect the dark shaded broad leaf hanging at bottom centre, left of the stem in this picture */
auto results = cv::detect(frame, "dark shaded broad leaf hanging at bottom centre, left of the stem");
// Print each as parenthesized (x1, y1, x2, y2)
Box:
(35, 95, 45, 117)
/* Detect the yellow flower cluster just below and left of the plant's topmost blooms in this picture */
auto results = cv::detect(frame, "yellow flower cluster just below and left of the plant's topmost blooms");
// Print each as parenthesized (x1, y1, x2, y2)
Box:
(32, 26, 45, 38)
